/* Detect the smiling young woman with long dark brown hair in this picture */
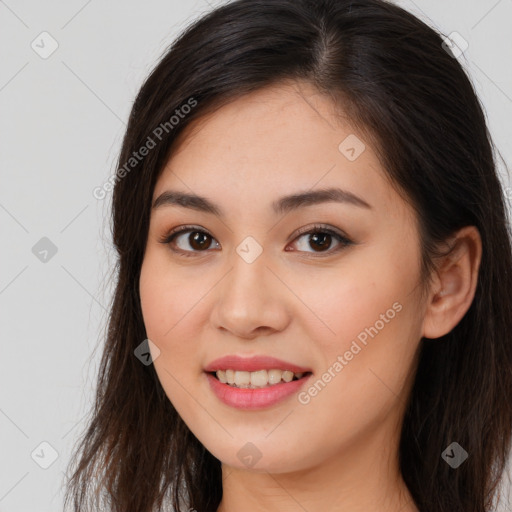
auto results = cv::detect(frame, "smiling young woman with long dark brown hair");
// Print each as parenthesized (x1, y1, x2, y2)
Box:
(66, 0, 512, 512)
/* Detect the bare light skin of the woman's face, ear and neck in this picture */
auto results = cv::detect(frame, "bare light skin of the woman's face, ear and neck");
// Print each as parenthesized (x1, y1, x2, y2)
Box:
(140, 83, 481, 512)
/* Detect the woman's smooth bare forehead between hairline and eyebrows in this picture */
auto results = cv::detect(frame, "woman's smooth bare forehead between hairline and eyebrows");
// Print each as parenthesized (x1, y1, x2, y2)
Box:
(153, 83, 399, 220)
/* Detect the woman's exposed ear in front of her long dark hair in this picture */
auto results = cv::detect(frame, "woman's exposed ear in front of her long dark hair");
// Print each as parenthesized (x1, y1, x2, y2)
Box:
(423, 226, 482, 338)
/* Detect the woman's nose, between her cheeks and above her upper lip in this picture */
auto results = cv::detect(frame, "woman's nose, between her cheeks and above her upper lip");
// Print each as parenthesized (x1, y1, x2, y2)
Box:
(211, 248, 291, 339)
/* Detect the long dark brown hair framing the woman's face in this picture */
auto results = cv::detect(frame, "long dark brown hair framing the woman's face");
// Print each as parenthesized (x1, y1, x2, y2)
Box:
(66, 0, 512, 512)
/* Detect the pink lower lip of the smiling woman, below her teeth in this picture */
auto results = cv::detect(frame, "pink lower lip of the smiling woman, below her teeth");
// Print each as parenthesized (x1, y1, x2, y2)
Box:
(206, 373, 312, 410)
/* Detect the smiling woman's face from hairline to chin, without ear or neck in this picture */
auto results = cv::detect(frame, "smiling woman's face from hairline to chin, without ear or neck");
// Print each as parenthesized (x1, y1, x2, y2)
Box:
(140, 84, 424, 473)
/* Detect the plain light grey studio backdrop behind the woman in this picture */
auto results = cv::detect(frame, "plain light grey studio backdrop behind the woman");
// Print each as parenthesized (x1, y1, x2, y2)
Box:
(0, 0, 512, 512)
